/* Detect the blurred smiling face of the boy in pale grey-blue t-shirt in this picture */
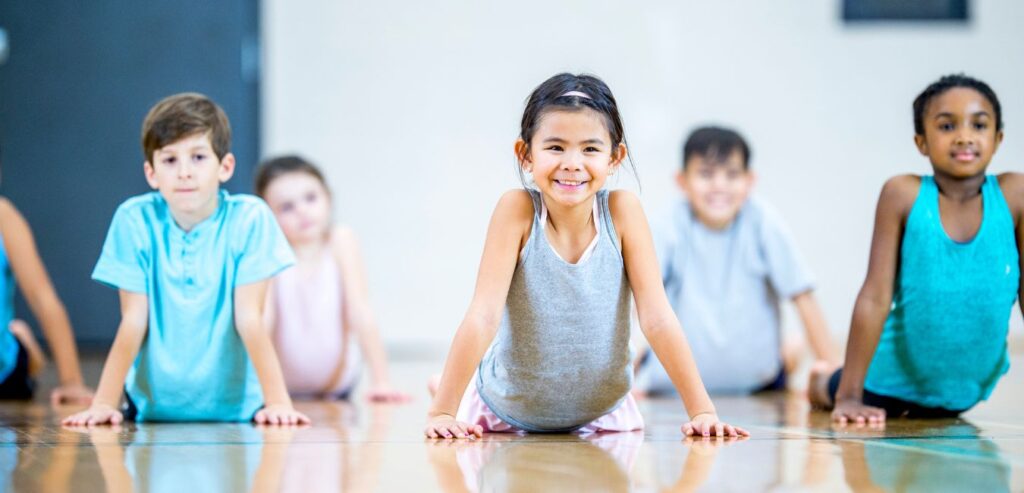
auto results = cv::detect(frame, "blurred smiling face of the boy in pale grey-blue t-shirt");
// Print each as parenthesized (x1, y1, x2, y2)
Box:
(677, 150, 755, 230)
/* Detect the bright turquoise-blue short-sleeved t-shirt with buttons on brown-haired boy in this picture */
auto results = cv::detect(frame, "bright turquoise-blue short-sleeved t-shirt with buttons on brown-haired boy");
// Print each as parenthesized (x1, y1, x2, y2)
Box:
(92, 191, 295, 421)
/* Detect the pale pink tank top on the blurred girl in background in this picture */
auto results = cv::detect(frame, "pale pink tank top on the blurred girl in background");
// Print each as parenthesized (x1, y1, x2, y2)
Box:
(273, 251, 359, 396)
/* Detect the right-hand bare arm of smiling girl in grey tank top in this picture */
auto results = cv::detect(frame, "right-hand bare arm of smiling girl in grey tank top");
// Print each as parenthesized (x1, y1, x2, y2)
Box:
(608, 191, 749, 437)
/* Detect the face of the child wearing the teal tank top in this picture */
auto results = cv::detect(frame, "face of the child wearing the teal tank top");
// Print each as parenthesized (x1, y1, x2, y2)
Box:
(913, 87, 1002, 178)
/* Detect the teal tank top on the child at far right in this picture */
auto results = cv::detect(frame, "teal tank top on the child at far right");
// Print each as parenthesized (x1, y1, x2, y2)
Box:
(864, 175, 1020, 411)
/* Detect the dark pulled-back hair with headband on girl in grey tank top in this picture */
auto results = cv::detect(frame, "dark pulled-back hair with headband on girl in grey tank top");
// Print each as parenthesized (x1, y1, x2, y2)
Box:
(516, 73, 639, 187)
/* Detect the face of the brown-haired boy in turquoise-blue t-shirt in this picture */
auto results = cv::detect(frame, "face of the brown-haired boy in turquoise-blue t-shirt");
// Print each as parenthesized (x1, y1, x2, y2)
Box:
(144, 132, 234, 231)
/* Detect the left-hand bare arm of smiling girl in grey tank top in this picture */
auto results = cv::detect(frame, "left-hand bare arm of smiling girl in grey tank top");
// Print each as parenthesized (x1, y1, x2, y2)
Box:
(424, 191, 534, 439)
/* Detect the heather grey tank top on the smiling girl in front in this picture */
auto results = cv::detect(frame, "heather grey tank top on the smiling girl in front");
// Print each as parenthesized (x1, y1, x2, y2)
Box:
(476, 190, 633, 433)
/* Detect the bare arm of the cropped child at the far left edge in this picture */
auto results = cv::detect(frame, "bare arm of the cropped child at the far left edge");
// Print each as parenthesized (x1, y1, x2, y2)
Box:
(0, 199, 92, 404)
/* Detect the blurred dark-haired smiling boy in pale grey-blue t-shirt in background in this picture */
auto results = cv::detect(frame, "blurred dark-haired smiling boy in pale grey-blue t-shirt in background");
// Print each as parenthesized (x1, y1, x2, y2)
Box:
(637, 127, 839, 394)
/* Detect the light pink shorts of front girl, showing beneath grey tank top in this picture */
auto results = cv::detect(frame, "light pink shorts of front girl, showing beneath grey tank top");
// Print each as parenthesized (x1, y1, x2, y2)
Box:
(456, 383, 643, 434)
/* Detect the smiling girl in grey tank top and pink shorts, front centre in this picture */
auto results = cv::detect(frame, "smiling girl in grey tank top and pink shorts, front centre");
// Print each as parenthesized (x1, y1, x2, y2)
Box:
(424, 74, 749, 438)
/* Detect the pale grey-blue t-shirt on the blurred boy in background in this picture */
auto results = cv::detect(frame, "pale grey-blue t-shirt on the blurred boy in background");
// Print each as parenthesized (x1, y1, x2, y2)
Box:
(637, 198, 813, 394)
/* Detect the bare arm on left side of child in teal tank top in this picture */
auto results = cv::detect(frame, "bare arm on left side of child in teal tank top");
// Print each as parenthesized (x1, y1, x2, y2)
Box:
(833, 175, 921, 423)
